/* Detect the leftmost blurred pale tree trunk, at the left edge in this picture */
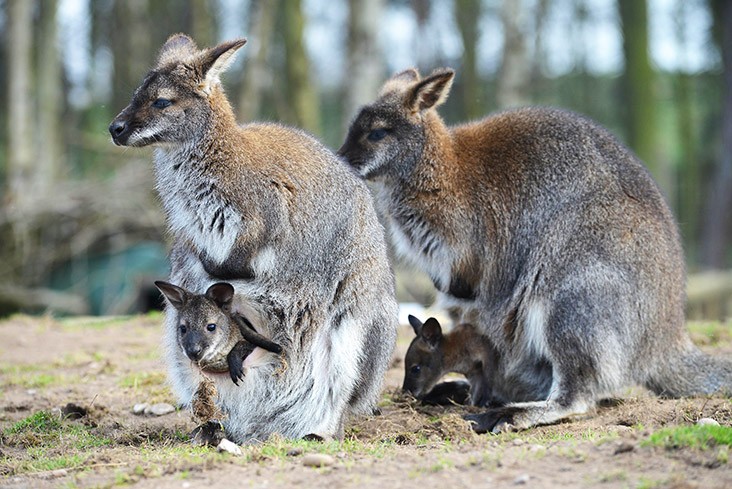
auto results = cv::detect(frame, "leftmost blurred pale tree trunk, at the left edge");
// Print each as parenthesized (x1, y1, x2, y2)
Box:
(6, 0, 36, 204)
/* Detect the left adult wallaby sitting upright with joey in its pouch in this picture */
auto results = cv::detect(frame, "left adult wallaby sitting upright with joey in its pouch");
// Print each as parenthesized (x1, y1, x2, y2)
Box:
(109, 34, 397, 443)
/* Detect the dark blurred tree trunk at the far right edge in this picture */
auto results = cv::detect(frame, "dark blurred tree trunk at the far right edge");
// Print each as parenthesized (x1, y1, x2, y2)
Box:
(701, 0, 732, 268)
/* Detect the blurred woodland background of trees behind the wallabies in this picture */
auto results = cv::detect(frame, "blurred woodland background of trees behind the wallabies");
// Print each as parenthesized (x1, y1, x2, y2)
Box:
(0, 0, 732, 318)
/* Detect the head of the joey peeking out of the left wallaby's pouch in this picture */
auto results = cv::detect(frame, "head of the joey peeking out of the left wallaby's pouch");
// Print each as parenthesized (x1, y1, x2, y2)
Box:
(155, 281, 238, 364)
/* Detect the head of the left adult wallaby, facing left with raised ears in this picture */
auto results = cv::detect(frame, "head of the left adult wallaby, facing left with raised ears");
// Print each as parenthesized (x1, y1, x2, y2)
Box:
(109, 34, 246, 147)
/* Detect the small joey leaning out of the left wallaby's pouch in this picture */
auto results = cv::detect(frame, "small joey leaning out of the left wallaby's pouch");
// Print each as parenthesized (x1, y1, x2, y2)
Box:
(155, 281, 282, 385)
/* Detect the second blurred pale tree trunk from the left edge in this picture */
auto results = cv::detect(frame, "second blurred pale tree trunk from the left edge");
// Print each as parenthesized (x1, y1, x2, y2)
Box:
(33, 0, 65, 192)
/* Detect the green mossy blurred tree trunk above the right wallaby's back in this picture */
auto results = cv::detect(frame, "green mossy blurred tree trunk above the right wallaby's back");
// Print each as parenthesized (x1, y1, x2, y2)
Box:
(618, 0, 673, 194)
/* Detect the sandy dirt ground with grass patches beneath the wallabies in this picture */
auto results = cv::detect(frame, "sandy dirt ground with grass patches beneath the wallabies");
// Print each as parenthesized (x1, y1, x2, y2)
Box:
(0, 315, 732, 489)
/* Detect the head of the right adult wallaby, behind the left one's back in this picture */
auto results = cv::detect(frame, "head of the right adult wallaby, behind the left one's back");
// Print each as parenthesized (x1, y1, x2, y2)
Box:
(338, 68, 455, 179)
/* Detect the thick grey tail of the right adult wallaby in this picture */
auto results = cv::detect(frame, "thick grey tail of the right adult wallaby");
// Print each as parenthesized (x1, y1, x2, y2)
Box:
(646, 341, 732, 397)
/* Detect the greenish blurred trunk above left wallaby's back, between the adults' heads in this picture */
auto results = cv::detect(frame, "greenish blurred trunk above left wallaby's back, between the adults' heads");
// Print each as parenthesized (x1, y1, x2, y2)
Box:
(283, 0, 320, 135)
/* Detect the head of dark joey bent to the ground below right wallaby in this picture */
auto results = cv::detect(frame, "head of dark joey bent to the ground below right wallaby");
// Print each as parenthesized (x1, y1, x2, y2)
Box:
(402, 315, 446, 399)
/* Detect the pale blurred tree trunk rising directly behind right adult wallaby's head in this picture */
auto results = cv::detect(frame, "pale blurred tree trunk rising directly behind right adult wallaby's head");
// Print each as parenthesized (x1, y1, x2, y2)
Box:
(342, 0, 384, 128)
